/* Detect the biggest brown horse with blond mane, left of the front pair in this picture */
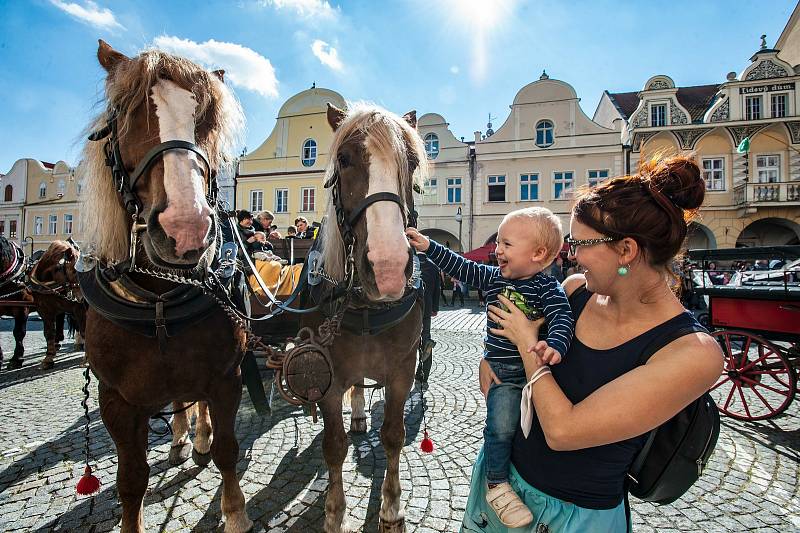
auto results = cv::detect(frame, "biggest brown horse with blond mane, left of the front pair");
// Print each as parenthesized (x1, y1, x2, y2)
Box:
(77, 40, 253, 533)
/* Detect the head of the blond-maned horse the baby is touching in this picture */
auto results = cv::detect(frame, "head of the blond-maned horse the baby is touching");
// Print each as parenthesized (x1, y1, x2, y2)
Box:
(323, 104, 427, 301)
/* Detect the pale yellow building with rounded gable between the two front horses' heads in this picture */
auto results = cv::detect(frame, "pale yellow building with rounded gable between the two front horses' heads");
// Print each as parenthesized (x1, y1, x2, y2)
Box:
(236, 87, 345, 234)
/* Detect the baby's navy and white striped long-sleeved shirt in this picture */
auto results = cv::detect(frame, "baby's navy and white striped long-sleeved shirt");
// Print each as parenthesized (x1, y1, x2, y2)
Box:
(426, 239, 575, 363)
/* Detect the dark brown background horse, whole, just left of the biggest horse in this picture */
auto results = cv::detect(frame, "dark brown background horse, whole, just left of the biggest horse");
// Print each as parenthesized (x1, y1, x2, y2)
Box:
(27, 241, 86, 370)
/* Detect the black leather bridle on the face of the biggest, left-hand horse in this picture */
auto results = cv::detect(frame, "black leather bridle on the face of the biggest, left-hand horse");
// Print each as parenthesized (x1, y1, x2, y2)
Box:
(89, 109, 219, 215)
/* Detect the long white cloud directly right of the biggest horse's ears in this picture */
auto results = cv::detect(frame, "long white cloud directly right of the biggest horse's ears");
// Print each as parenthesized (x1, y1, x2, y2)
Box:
(153, 35, 278, 98)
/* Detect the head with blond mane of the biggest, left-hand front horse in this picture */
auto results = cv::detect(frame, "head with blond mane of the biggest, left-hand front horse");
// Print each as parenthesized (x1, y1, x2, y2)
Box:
(85, 40, 243, 269)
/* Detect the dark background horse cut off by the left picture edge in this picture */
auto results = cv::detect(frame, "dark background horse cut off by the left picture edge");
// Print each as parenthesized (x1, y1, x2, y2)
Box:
(0, 235, 33, 368)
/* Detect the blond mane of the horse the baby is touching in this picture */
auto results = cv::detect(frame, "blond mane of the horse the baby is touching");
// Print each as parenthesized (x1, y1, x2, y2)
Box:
(319, 102, 428, 279)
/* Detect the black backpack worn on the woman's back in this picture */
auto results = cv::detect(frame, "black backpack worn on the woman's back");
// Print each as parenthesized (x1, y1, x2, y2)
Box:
(625, 325, 719, 504)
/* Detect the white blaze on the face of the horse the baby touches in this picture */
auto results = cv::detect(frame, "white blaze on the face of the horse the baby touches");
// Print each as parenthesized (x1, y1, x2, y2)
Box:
(365, 148, 409, 300)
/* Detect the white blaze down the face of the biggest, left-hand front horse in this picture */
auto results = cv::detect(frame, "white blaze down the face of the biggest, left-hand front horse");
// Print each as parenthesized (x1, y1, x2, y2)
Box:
(151, 80, 211, 257)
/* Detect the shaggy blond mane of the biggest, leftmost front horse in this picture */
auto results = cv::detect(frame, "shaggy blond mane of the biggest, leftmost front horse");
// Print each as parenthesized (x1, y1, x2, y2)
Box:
(78, 49, 244, 261)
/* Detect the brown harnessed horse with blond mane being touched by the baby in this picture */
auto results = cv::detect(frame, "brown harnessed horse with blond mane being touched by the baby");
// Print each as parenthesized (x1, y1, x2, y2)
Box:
(301, 104, 427, 533)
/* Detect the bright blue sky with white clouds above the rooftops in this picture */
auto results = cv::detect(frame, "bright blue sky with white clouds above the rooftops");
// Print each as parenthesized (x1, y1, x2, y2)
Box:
(0, 0, 796, 173)
